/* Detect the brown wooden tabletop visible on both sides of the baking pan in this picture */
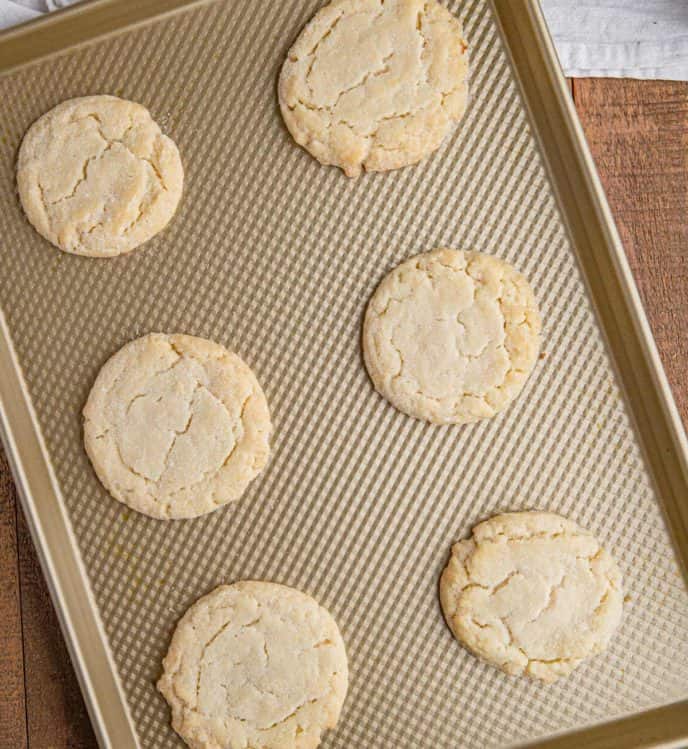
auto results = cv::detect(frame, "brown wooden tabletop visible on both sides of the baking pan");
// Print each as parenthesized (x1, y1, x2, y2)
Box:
(0, 79, 688, 749)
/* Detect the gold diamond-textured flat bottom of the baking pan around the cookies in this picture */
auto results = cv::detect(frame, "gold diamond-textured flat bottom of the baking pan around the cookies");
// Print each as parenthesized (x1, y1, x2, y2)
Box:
(0, 0, 688, 749)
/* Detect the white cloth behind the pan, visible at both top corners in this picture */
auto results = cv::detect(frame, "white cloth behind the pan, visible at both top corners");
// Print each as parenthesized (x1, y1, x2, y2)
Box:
(0, 0, 688, 81)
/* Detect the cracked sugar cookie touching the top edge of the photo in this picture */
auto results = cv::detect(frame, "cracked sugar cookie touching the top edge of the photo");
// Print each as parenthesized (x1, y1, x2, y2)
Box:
(279, 0, 468, 177)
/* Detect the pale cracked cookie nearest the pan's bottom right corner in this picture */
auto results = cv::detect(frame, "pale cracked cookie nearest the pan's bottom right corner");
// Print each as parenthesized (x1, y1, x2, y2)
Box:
(440, 512, 623, 682)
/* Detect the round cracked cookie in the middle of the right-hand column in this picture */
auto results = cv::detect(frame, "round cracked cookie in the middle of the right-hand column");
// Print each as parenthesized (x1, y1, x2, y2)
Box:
(363, 249, 541, 424)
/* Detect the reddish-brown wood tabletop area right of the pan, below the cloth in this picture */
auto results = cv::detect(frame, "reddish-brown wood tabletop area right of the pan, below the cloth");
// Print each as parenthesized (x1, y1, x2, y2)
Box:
(574, 78, 688, 424)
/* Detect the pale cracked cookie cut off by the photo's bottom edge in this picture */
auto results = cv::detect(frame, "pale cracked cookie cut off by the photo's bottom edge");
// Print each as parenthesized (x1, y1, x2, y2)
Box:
(158, 581, 348, 749)
